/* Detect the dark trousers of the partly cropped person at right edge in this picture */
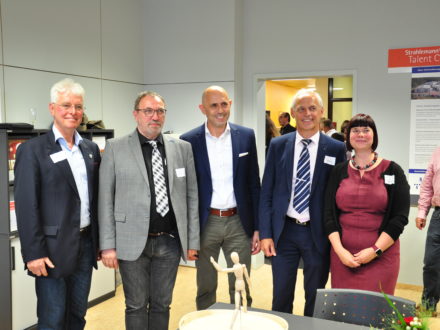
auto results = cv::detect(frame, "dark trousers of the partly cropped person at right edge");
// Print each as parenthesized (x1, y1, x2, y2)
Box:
(422, 209, 440, 310)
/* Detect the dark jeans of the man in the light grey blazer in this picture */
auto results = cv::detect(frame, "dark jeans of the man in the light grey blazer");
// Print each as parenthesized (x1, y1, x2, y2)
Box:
(119, 235, 181, 330)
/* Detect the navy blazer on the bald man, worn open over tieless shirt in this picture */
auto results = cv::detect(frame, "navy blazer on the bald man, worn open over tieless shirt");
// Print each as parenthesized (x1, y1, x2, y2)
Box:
(180, 123, 260, 237)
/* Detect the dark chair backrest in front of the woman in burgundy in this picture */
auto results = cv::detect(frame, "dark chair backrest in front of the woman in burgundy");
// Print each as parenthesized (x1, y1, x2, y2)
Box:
(313, 289, 416, 328)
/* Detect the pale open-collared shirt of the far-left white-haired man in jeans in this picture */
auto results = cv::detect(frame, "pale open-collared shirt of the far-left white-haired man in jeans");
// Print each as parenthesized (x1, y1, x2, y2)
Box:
(52, 125, 90, 228)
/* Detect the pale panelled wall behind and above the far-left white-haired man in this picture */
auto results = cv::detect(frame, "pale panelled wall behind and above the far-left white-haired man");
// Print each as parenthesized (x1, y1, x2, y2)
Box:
(0, 0, 144, 136)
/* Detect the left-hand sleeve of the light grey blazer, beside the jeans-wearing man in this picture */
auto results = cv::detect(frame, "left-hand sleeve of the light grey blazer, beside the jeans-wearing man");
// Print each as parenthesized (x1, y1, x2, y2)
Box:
(98, 141, 116, 250)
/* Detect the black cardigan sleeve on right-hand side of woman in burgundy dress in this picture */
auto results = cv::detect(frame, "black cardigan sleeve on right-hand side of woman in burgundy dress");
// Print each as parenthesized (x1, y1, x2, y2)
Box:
(383, 162, 410, 240)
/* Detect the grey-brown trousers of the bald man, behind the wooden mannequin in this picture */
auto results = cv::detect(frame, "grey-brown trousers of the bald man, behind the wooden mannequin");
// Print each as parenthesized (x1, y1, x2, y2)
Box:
(196, 214, 252, 310)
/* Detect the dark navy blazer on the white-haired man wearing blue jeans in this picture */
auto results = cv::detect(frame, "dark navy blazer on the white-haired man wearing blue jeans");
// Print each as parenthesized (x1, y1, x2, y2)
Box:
(14, 130, 101, 278)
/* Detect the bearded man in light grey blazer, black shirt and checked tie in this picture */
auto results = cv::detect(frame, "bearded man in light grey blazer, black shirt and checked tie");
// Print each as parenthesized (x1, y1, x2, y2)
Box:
(99, 91, 199, 330)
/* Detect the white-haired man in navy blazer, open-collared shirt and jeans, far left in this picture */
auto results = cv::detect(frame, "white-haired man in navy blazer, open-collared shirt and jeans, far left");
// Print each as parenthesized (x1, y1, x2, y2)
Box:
(14, 79, 101, 330)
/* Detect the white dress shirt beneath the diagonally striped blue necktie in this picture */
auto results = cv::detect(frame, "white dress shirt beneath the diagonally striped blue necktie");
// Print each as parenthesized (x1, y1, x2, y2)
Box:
(287, 131, 319, 222)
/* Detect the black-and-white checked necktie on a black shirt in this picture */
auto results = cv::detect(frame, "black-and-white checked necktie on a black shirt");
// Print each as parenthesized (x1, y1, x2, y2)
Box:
(148, 141, 170, 217)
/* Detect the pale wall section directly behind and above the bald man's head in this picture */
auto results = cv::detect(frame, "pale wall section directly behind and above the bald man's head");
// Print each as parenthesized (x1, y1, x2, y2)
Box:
(144, 0, 240, 134)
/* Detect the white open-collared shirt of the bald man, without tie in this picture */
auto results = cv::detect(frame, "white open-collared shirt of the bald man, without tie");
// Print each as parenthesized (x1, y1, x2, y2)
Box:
(205, 123, 237, 210)
